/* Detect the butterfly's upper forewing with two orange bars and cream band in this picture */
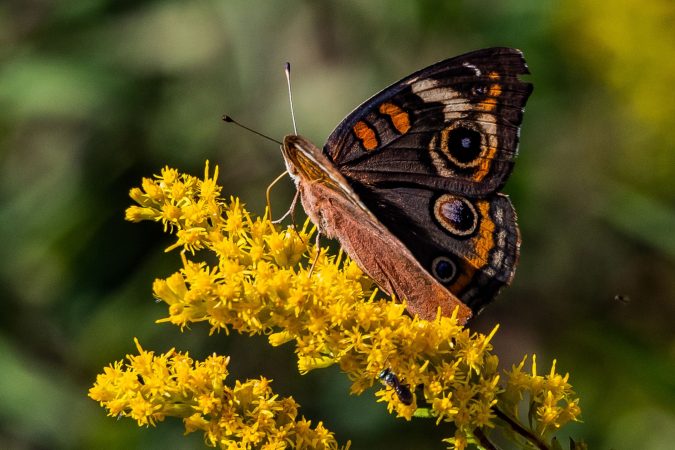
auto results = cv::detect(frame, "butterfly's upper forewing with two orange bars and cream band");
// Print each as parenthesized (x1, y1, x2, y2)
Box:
(324, 48, 531, 196)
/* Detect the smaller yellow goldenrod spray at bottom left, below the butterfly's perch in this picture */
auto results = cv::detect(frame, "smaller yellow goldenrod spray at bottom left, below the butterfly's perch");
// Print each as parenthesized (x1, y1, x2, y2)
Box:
(89, 340, 338, 450)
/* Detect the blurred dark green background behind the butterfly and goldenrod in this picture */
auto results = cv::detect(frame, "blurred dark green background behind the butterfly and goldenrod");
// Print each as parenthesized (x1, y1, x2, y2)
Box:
(0, 0, 675, 449)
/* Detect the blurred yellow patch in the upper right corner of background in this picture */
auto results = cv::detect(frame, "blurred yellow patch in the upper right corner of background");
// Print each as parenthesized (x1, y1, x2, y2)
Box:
(561, 0, 675, 201)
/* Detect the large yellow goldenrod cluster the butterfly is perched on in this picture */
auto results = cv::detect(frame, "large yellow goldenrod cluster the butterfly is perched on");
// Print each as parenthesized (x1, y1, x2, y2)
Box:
(95, 163, 580, 449)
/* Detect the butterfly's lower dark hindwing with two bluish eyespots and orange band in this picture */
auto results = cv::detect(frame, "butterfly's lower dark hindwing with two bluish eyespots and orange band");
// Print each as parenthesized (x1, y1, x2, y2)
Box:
(354, 184, 520, 312)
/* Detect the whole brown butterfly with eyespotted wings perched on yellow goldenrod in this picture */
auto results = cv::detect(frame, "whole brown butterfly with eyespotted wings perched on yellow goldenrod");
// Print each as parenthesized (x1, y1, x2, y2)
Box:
(282, 48, 532, 323)
